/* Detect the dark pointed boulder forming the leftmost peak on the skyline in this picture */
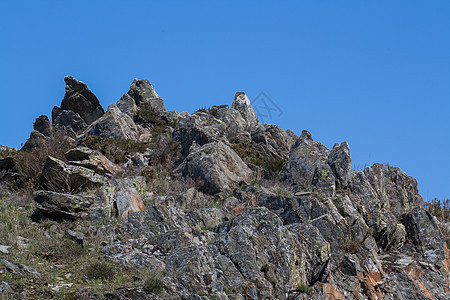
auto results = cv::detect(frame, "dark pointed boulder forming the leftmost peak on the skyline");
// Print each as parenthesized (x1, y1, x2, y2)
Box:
(52, 76, 105, 125)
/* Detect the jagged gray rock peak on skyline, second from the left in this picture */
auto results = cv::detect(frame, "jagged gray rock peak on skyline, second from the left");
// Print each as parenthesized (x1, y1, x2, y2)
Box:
(127, 78, 166, 113)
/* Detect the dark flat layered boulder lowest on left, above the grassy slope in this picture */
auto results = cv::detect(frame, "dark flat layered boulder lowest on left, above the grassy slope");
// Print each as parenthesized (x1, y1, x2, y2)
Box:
(33, 191, 95, 220)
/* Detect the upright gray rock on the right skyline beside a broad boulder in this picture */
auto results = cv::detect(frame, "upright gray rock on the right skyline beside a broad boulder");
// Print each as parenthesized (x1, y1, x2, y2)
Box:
(327, 142, 352, 188)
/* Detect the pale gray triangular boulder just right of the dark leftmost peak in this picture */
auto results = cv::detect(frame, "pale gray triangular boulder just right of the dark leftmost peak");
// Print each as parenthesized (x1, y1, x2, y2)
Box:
(78, 104, 139, 140)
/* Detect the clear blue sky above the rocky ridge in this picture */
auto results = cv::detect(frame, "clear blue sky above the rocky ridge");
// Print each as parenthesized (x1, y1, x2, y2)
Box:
(0, 0, 450, 199)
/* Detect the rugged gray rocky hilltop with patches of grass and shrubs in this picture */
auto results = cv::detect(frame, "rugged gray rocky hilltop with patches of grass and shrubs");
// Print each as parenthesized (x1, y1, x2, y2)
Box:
(0, 76, 450, 300)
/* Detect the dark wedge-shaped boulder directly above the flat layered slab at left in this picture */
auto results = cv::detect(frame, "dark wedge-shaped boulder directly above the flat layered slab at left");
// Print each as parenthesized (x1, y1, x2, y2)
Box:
(38, 156, 107, 193)
